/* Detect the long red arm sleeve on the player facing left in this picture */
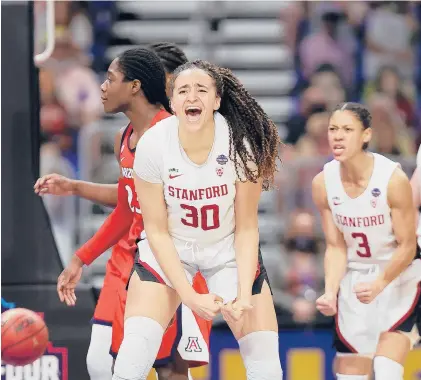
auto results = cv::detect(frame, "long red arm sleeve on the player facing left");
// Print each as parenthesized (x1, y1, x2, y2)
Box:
(76, 181, 133, 265)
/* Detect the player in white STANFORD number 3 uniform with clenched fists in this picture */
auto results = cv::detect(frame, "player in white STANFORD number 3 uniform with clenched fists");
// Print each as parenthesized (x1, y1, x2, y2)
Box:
(313, 103, 421, 380)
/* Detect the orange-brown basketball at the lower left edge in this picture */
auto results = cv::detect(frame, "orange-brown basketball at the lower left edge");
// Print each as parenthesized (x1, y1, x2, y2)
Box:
(1, 308, 48, 366)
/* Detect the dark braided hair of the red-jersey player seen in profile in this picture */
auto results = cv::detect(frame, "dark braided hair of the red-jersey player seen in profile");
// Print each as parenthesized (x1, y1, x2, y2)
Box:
(118, 48, 172, 113)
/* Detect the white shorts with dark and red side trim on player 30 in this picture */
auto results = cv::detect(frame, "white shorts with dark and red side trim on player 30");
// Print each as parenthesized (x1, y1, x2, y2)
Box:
(135, 239, 269, 302)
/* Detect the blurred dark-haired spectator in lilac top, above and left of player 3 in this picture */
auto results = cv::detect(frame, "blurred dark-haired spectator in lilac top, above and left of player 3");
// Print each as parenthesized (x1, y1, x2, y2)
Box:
(299, 9, 356, 87)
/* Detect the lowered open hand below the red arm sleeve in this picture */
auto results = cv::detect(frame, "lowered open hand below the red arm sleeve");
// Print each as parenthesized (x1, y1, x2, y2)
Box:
(57, 255, 83, 306)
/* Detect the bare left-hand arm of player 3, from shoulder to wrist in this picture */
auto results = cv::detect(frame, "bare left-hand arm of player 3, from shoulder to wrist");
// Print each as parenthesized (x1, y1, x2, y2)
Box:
(312, 172, 347, 297)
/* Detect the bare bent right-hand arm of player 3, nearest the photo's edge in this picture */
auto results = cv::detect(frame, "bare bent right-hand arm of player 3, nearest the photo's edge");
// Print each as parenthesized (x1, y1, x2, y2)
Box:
(377, 168, 416, 287)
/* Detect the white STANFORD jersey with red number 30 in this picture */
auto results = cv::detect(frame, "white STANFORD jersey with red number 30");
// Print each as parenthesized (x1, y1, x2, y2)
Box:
(133, 113, 238, 267)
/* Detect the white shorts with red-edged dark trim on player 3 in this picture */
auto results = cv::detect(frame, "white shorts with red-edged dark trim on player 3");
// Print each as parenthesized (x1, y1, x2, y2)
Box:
(334, 260, 421, 355)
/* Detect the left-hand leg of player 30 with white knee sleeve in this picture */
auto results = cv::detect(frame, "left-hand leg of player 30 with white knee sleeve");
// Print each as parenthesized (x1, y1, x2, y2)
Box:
(113, 256, 180, 380)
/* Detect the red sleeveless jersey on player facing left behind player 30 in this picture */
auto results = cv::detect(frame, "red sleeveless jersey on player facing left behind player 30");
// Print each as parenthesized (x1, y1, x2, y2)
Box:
(118, 110, 171, 250)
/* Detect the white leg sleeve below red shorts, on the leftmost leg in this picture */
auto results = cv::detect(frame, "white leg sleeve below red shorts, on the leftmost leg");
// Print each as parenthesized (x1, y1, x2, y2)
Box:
(86, 323, 113, 380)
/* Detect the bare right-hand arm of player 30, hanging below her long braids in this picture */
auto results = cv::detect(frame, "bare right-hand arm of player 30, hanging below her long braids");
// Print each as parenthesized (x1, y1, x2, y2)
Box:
(234, 180, 262, 303)
